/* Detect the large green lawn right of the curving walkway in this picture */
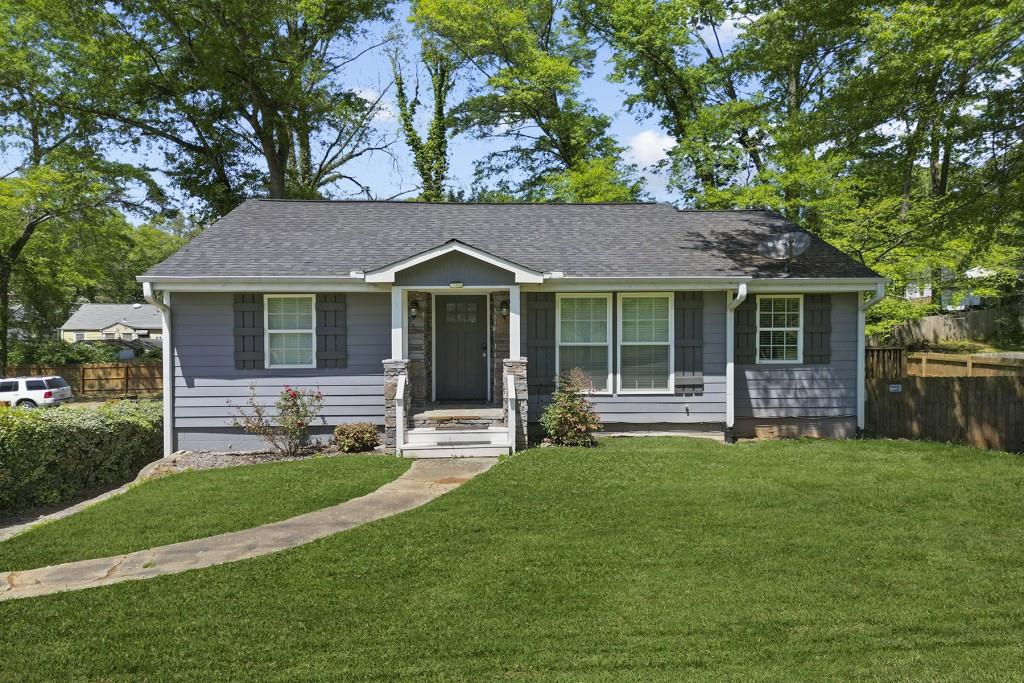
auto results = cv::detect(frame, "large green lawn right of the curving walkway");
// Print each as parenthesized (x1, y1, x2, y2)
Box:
(0, 438, 1024, 682)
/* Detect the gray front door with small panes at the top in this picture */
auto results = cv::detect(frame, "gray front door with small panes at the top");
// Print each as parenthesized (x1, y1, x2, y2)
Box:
(434, 295, 487, 400)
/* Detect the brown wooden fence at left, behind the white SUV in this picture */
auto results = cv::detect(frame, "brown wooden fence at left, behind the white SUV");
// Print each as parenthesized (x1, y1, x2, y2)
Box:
(7, 362, 164, 398)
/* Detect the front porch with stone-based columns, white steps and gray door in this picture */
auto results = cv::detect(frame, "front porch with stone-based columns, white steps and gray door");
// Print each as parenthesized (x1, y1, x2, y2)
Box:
(384, 285, 527, 458)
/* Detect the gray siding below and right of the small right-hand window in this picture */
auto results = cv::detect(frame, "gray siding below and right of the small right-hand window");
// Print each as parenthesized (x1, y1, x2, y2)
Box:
(735, 293, 857, 423)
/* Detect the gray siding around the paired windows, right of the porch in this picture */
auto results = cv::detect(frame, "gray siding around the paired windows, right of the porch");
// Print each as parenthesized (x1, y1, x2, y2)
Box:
(524, 292, 726, 424)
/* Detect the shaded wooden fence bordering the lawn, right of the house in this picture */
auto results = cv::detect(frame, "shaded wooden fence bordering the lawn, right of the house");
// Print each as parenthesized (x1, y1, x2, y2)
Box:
(865, 377, 1024, 453)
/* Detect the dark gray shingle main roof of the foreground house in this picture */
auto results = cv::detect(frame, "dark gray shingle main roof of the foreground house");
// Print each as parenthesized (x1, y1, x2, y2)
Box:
(140, 200, 879, 280)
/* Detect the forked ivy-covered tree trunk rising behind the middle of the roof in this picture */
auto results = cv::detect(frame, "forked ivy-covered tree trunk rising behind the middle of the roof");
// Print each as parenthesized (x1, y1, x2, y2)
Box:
(390, 41, 460, 202)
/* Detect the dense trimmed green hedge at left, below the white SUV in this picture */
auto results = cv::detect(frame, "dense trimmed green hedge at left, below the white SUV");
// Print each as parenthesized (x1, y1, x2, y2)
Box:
(0, 401, 163, 512)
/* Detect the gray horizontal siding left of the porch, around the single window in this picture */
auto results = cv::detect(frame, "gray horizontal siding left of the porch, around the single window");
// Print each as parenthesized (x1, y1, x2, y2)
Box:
(171, 293, 390, 450)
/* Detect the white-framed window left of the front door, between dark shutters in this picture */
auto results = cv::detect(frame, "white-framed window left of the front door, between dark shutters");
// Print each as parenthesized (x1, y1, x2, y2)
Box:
(263, 294, 316, 368)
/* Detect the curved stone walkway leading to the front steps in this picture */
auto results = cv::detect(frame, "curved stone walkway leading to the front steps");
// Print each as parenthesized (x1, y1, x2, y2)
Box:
(0, 458, 497, 601)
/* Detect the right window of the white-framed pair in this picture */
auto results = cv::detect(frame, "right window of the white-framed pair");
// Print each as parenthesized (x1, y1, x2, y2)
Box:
(618, 292, 673, 393)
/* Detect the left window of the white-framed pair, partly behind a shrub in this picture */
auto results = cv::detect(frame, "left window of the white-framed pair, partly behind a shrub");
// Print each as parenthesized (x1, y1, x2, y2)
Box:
(555, 294, 611, 391)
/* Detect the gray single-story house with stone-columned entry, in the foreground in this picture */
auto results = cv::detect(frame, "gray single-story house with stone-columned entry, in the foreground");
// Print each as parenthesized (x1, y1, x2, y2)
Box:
(139, 200, 885, 456)
